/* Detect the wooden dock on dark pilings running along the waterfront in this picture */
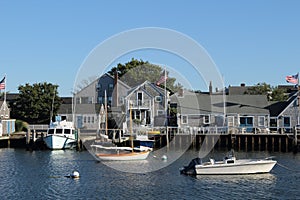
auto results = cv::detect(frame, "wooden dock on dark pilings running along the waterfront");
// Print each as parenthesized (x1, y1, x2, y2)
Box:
(0, 127, 300, 153)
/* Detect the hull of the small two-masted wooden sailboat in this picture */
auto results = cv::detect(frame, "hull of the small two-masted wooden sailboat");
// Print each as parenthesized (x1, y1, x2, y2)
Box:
(96, 151, 150, 161)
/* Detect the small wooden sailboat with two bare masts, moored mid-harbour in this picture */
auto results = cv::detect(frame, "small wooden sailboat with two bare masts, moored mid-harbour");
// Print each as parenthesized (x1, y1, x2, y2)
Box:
(91, 93, 150, 161)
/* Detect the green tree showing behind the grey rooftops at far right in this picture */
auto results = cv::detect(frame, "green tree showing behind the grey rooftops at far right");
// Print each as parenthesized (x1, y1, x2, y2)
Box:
(245, 83, 287, 101)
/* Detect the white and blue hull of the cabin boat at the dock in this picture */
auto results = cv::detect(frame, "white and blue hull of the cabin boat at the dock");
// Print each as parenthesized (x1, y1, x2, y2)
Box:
(44, 135, 77, 150)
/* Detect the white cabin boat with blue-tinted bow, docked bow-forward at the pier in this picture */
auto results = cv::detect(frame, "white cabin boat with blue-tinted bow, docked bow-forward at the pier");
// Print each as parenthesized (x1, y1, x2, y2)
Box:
(44, 120, 77, 150)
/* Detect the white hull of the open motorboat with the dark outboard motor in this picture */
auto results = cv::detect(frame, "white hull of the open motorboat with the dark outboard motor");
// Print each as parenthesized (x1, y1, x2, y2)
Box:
(195, 160, 277, 175)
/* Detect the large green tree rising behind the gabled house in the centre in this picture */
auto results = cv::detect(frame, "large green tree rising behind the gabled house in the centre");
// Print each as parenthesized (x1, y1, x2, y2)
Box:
(108, 58, 182, 92)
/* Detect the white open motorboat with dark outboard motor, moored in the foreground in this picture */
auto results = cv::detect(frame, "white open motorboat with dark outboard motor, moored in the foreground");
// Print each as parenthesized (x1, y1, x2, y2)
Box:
(180, 152, 277, 175)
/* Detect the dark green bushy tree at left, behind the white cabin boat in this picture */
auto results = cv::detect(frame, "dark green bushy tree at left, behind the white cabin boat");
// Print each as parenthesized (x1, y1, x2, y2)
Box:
(10, 82, 61, 124)
